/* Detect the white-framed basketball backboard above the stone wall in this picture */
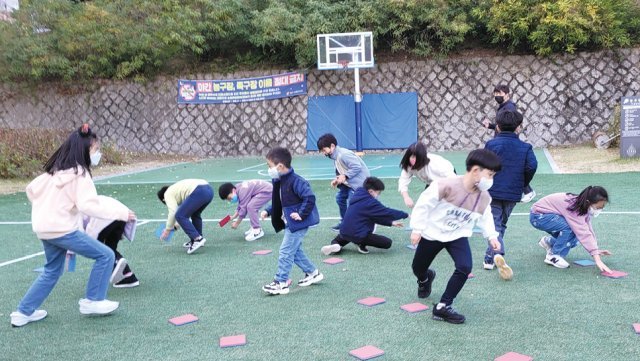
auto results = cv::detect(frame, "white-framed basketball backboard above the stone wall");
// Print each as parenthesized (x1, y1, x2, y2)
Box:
(317, 31, 374, 70)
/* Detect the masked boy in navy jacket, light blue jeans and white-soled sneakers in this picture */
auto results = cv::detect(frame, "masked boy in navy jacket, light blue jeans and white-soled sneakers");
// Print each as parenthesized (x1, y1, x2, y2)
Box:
(262, 148, 324, 295)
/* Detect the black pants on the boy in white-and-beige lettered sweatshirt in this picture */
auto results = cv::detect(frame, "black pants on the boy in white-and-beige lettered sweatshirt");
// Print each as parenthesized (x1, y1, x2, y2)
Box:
(412, 237, 472, 305)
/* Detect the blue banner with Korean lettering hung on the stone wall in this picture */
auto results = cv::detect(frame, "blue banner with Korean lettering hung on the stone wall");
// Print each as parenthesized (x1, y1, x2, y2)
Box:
(178, 73, 307, 104)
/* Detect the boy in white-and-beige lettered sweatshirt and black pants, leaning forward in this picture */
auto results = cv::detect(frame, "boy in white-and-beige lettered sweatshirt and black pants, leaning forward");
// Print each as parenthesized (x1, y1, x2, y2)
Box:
(410, 149, 513, 323)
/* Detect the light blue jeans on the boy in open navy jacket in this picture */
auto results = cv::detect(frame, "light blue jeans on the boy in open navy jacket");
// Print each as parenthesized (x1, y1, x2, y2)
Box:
(275, 228, 316, 282)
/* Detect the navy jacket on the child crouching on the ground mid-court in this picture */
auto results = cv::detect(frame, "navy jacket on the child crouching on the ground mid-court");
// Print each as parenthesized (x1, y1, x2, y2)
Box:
(340, 187, 409, 243)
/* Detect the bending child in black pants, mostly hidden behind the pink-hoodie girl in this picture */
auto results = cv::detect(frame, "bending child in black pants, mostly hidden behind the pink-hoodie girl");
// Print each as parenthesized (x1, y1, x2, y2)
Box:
(85, 196, 140, 288)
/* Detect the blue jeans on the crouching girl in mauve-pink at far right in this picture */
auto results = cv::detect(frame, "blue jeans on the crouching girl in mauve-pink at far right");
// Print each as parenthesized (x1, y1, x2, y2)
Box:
(529, 212, 578, 257)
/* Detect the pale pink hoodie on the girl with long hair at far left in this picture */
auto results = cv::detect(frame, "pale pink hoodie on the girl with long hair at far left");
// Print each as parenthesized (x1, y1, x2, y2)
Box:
(27, 167, 129, 239)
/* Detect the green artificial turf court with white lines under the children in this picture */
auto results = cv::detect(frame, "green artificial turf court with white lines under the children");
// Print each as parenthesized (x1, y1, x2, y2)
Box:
(0, 152, 640, 360)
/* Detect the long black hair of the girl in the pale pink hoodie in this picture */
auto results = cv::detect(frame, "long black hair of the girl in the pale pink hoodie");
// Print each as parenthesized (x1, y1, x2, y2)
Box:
(44, 124, 98, 175)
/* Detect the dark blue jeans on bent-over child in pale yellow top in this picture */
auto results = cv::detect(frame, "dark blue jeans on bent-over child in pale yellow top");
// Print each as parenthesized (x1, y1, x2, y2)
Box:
(176, 184, 213, 240)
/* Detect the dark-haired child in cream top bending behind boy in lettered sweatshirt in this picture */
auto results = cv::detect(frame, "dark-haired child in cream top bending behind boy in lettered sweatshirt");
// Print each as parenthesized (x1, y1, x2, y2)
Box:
(398, 142, 456, 208)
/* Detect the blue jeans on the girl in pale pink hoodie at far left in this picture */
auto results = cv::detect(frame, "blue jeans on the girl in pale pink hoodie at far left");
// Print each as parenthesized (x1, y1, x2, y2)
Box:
(18, 231, 115, 315)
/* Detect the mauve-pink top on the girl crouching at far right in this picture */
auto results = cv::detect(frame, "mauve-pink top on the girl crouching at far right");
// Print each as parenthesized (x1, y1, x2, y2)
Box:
(531, 193, 600, 256)
